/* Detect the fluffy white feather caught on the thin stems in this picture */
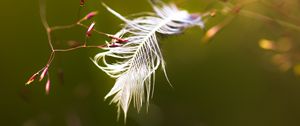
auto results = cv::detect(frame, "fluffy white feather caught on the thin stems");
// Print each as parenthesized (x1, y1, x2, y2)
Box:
(93, 2, 203, 119)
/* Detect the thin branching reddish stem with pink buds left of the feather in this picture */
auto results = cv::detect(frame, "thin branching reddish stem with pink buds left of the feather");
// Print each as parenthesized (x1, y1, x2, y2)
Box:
(26, 0, 127, 88)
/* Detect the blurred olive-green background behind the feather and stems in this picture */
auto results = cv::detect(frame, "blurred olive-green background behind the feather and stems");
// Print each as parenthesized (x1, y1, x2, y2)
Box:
(0, 0, 300, 126)
